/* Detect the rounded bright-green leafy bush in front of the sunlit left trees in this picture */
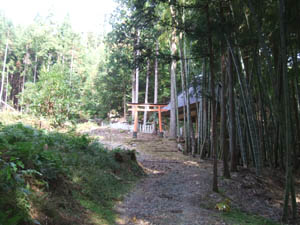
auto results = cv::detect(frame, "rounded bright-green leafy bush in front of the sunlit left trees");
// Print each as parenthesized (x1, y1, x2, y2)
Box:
(23, 65, 80, 125)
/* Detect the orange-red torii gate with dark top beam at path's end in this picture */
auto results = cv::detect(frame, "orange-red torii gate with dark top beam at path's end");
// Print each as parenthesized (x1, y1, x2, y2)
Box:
(127, 103, 168, 138)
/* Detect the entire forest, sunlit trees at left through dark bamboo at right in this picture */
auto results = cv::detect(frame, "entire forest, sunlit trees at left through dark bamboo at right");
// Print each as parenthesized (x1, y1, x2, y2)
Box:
(0, 0, 300, 220)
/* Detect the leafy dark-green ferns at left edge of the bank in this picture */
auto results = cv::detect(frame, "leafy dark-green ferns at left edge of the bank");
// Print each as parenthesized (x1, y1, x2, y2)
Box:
(0, 124, 64, 224)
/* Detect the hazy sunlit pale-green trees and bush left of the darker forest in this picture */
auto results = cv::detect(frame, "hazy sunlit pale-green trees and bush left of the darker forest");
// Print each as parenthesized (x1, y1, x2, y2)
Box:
(0, 13, 107, 121)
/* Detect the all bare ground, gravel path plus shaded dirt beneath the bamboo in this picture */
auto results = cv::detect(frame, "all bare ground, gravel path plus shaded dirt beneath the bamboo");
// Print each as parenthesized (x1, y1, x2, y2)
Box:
(89, 128, 300, 225)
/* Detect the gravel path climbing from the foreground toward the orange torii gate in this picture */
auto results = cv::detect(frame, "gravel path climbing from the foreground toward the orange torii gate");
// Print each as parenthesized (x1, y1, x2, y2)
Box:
(110, 133, 226, 225)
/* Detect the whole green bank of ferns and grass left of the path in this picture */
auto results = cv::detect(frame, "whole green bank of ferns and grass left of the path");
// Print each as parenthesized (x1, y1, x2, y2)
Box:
(0, 123, 143, 225)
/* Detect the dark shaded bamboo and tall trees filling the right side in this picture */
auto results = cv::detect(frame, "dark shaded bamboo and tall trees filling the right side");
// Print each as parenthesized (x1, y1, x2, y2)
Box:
(110, 0, 300, 220)
